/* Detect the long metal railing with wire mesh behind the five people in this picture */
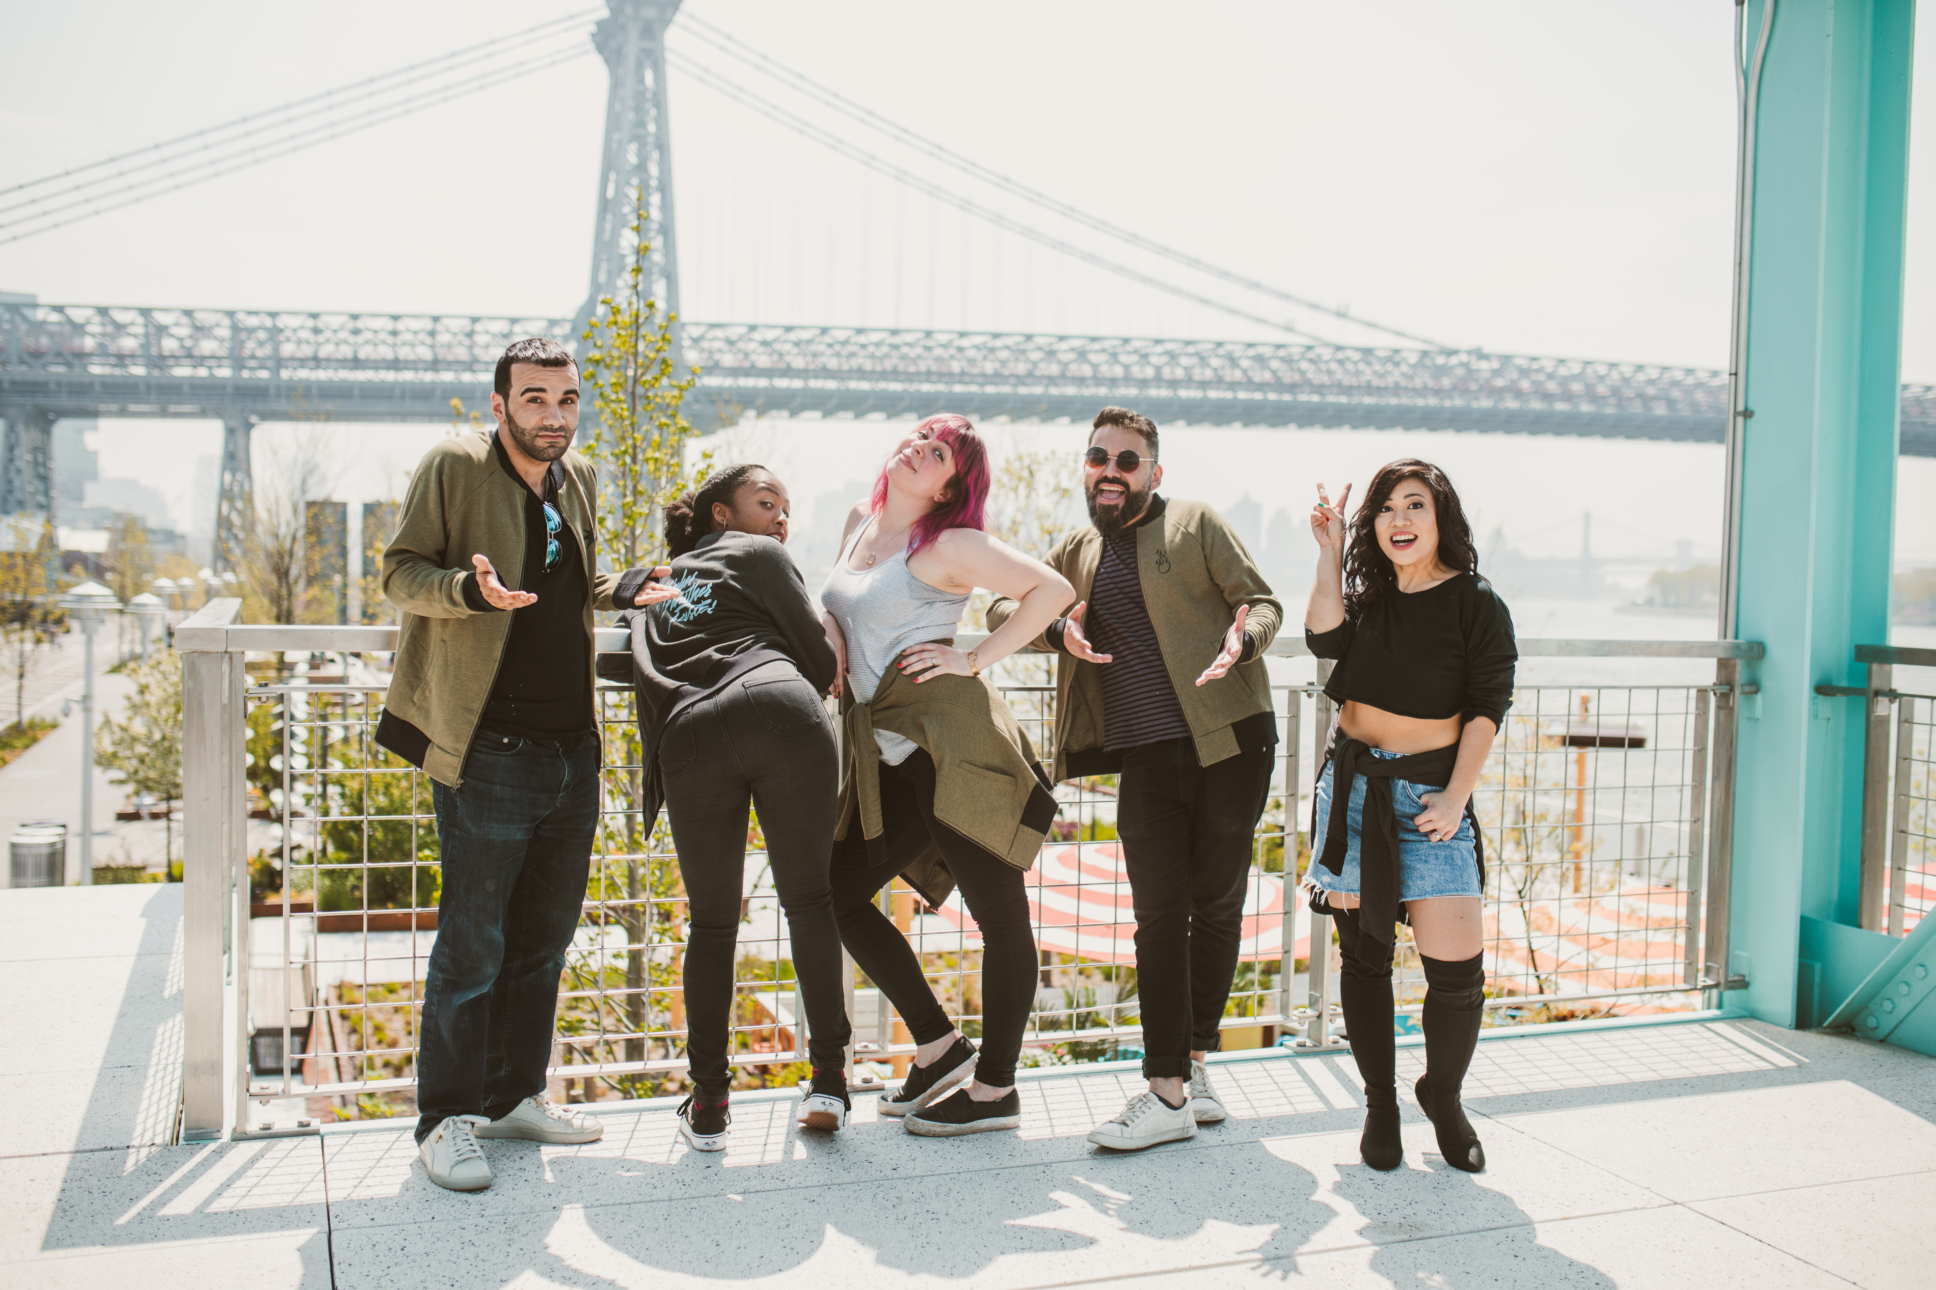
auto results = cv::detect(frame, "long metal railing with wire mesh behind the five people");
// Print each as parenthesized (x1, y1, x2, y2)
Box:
(176, 600, 1760, 1137)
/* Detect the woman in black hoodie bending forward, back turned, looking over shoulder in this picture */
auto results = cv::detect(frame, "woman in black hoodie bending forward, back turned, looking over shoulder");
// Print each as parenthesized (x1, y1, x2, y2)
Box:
(631, 465, 848, 1151)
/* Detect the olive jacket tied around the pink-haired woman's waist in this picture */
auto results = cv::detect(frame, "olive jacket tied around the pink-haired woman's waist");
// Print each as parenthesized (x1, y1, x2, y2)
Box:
(834, 641, 1055, 908)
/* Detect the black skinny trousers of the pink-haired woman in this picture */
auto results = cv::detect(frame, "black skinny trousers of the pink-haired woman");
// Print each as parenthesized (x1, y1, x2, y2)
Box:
(834, 748, 1036, 1089)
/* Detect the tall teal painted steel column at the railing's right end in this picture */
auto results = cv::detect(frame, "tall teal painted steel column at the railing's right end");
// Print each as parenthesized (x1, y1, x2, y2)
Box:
(1729, 0, 1915, 1025)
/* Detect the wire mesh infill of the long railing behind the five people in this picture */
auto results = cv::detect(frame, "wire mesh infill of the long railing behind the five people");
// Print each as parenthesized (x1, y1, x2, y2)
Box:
(246, 655, 1726, 1116)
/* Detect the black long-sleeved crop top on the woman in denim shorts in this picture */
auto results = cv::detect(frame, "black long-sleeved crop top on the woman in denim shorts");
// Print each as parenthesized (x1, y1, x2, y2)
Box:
(1305, 573, 1520, 726)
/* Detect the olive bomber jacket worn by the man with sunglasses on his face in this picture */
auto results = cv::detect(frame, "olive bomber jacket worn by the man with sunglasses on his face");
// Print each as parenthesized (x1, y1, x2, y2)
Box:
(987, 496, 1284, 781)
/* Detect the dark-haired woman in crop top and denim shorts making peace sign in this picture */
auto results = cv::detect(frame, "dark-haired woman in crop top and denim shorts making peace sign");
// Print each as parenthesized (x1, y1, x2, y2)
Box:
(1305, 457, 1518, 1172)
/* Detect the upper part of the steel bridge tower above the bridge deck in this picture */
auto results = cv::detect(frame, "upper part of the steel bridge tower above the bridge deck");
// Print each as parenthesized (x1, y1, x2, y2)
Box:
(573, 0, 680, 344)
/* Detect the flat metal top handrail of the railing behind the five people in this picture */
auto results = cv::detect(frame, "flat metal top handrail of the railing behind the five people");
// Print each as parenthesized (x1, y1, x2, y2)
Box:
(174, 614, 1773, 666)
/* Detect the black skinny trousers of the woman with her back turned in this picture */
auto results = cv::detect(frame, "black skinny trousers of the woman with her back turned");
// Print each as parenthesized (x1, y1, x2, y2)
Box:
(658, 662, 850, 1094)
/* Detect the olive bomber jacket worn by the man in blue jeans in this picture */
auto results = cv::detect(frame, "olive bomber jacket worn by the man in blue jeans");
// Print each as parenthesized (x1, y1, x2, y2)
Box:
(383, 430, 643, 786)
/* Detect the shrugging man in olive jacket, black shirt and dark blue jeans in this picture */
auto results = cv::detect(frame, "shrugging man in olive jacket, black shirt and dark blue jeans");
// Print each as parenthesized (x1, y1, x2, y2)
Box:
(376, 339, 678, 1191)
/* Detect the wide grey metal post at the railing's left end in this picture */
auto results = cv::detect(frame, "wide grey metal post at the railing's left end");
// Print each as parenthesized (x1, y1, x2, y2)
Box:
(174, 599, 246, 1143)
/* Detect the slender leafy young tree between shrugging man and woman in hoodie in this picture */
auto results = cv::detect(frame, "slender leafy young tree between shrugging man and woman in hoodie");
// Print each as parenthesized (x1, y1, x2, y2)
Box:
(573, 178, 705, 1094)
